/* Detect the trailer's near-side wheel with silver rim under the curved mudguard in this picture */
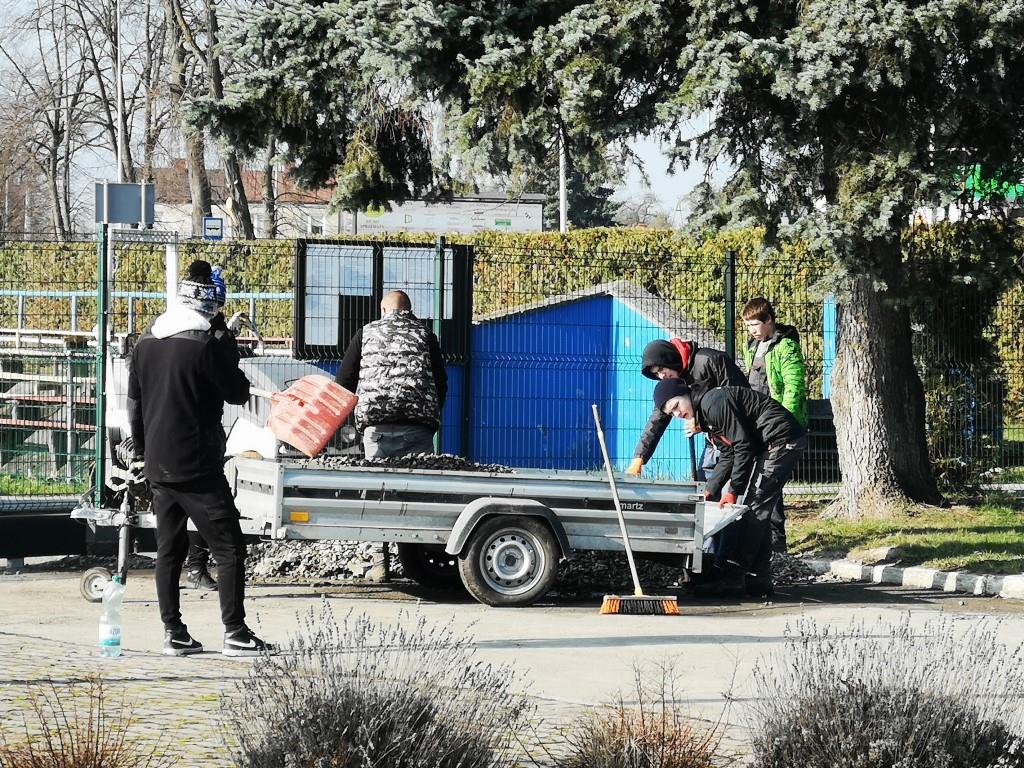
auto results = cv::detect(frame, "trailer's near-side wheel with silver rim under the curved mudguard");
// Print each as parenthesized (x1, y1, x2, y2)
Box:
(459, 516, 559, 607)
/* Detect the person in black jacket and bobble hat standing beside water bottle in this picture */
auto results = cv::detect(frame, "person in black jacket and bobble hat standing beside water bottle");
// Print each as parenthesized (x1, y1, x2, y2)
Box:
(128, 261, 268, 655)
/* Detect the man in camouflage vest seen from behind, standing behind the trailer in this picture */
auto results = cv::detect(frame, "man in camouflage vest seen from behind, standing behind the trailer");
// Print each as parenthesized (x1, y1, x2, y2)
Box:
(335, 291, 447, 582)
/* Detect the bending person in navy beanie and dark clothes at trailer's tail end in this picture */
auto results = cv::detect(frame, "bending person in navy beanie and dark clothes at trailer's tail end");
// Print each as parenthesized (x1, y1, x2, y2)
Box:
(654, 379, 807, 596)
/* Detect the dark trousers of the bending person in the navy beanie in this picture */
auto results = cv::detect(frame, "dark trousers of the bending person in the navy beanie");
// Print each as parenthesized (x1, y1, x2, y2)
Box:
(732, 436, 807, 575)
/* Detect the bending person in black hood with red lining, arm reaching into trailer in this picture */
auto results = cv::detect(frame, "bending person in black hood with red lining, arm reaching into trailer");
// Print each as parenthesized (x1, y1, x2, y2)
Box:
(626, 339, 748, 479)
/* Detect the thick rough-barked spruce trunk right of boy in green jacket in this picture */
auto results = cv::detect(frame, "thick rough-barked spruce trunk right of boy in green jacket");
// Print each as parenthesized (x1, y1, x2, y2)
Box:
(829, 241, 942, 517)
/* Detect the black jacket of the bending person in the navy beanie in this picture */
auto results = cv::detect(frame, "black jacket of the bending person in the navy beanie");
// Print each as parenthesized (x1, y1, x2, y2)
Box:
(694, 387, 805, 498)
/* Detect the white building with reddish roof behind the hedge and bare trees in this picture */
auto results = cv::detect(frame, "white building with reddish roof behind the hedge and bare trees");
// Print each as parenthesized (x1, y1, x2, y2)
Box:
(154, 161, 545, 239)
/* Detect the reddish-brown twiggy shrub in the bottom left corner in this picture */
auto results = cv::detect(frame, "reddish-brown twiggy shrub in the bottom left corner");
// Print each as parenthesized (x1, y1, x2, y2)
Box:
(0, 678, 175, 768)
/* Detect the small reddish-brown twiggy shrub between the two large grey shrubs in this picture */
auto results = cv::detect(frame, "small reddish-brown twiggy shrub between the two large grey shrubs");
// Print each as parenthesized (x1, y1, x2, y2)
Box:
(558, 666, 721, 768)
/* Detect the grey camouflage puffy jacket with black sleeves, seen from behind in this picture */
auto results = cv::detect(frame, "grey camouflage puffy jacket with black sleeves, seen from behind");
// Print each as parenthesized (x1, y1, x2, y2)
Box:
(336, 309, 447, 431)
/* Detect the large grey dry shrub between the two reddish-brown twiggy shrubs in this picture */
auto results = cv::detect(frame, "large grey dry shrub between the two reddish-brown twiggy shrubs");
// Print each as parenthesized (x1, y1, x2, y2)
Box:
(221, 603, 532, 768)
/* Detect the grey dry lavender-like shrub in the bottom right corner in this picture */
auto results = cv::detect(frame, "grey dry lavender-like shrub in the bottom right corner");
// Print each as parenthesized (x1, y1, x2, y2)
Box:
(751, 616, 1024, 768)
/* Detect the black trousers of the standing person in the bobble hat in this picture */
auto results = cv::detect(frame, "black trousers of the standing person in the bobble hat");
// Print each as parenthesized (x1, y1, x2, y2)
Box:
(153, 475, 246, 632)
